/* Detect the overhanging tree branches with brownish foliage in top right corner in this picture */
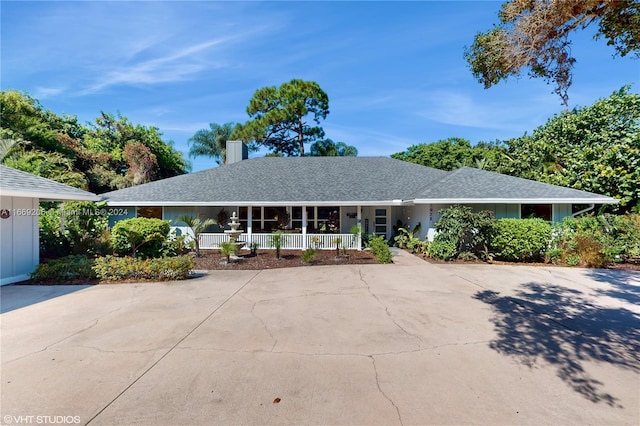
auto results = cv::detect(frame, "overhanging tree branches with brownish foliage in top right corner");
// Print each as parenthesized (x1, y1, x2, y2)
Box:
(465, 0, 640, 105)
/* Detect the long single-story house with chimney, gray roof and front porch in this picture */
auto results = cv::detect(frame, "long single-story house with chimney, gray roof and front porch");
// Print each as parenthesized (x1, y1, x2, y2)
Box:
(102, 142, 617, 248)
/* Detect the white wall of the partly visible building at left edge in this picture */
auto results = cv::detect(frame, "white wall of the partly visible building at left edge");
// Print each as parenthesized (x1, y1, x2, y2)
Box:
(0, 196, 40, 285)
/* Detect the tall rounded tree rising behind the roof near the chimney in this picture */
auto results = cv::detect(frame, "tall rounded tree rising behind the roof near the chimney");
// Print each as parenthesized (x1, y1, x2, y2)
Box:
(233, 79, 329, 156)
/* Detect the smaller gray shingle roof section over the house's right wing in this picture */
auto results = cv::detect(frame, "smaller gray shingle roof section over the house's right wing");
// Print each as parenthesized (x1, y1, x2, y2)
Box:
(411, 167, 613, 203)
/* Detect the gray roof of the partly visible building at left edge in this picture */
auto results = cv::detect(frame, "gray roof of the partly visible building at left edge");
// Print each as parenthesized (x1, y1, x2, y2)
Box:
(0, 165, 100, 201)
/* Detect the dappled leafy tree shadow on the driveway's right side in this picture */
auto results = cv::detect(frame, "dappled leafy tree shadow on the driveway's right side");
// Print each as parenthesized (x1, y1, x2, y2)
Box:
(474, 282, 640, 406)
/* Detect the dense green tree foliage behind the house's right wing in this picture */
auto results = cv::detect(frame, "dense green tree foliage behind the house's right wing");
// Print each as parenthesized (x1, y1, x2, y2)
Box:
(497, 86, 640, 211)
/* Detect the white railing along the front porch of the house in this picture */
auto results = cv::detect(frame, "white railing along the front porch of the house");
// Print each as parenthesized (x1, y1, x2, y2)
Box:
(199, 233, 361, 250)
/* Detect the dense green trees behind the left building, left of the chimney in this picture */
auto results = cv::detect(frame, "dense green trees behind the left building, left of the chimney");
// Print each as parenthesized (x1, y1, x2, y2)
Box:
(0, 91, 189, 193)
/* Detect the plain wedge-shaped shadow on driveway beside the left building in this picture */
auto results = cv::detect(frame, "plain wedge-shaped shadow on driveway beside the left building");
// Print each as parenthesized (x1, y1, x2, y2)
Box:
(0, 284, 91, 313)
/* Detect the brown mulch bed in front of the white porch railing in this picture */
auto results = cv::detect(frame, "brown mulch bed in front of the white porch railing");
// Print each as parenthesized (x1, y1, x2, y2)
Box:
(194, 250, 378, 270)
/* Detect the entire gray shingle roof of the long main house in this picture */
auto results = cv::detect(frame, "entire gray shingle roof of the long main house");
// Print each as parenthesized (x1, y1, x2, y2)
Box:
(103, 157, 613, 205)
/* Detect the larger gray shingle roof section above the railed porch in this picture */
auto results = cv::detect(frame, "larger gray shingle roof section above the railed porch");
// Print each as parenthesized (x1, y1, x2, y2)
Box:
(103, 157, 446, 203)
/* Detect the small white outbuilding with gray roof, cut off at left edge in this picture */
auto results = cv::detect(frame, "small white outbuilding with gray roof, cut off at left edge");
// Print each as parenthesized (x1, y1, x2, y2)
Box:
(0, 165, 100, 285)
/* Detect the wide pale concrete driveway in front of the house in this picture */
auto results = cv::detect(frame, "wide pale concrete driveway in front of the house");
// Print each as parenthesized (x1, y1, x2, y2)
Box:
(0, 254, 640, 425)
